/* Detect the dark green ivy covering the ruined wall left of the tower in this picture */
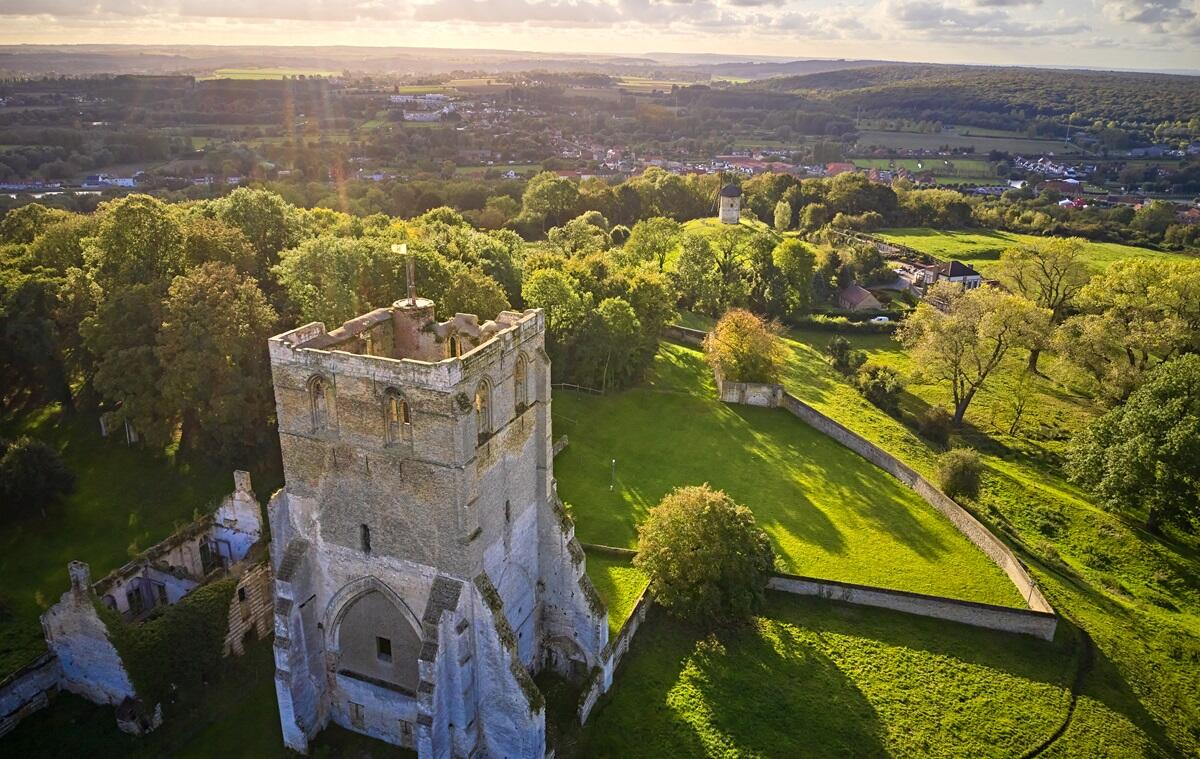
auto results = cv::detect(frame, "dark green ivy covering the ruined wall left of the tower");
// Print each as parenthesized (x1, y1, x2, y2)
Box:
(96, 578, 238, 709)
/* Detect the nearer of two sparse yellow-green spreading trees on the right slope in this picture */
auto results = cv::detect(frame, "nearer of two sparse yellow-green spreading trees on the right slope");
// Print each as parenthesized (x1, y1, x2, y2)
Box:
(896, 282, 1050, 424)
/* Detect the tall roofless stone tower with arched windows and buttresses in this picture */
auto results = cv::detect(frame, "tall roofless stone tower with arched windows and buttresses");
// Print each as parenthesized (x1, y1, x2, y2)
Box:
(269, 291, 608, 758)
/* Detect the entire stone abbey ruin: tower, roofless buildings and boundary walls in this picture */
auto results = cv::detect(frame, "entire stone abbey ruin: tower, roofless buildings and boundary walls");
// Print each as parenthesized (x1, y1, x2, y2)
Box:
(0, 293, 1057, 758)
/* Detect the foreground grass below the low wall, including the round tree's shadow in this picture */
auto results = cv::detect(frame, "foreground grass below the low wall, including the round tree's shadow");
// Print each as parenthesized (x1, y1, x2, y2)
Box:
(578, 593, 1074, 758)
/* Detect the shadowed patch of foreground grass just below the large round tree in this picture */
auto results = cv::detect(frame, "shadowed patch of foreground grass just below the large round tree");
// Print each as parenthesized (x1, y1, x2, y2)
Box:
(576, 609, 887, 758)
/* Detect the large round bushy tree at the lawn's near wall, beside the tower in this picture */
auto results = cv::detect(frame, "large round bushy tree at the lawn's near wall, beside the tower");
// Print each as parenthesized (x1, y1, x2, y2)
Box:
(634, 484, 775, 623)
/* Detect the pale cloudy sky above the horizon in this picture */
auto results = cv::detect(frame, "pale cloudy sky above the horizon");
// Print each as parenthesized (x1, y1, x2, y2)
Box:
(0, 0, 1200, 68)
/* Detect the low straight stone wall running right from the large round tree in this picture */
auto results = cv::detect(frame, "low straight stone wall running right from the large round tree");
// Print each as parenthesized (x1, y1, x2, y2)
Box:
(767, 574, 1058, 640)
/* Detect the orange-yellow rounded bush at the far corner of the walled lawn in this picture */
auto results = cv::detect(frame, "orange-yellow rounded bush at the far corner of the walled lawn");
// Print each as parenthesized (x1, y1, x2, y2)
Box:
(704, 309, 784, 382)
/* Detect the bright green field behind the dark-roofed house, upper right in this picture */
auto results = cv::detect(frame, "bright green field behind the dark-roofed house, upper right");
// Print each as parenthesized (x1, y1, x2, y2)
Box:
(878, 227, 1195, 275)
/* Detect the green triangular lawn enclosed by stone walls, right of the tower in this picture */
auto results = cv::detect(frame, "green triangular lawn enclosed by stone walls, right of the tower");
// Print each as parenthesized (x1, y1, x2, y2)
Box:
(554, 343, 1022, 605)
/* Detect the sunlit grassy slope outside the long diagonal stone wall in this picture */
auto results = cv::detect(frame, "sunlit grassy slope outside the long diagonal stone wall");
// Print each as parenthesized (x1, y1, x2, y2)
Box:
(768, 319, 1200, 757)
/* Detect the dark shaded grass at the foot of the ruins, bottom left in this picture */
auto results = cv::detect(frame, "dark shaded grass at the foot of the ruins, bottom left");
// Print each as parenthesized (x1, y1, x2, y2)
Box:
(0, 640, 416, 759)
